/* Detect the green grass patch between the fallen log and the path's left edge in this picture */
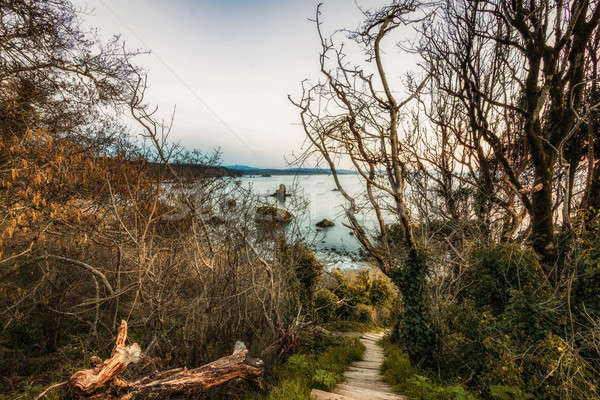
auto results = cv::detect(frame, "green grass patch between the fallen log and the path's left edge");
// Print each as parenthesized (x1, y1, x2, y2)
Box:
(267, 335, 365, 400)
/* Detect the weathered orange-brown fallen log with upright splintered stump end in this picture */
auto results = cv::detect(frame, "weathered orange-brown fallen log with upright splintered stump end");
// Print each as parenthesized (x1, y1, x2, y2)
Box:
(67, 321, 264, 400)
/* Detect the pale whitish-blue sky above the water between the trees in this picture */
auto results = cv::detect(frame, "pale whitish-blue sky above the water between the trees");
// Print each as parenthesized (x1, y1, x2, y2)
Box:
(74, 0, 414, 168)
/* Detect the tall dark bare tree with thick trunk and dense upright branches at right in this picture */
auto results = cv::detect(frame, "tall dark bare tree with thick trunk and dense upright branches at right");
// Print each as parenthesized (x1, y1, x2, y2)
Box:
(420, 1, 600, 281)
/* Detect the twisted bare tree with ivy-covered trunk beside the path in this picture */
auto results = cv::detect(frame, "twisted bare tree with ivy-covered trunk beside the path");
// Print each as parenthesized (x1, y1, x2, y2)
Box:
(290, 1, 435, 365)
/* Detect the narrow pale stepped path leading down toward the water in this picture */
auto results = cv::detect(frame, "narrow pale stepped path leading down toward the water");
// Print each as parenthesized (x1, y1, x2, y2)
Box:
(311, 333, 406, 400)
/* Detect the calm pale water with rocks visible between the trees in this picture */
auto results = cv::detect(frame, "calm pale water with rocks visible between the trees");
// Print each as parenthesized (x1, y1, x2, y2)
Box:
(239, 175, 386, 268)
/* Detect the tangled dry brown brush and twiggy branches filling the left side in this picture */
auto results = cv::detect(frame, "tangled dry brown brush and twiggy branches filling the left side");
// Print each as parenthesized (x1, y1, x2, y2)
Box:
(0, 0, 328, 397)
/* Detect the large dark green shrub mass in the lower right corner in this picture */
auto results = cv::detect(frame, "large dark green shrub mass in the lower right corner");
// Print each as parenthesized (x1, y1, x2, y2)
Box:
(440, 244, 598, 399)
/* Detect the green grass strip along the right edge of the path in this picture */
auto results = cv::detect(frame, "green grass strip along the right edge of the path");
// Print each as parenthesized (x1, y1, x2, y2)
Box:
(381, 339, 477, 400)
